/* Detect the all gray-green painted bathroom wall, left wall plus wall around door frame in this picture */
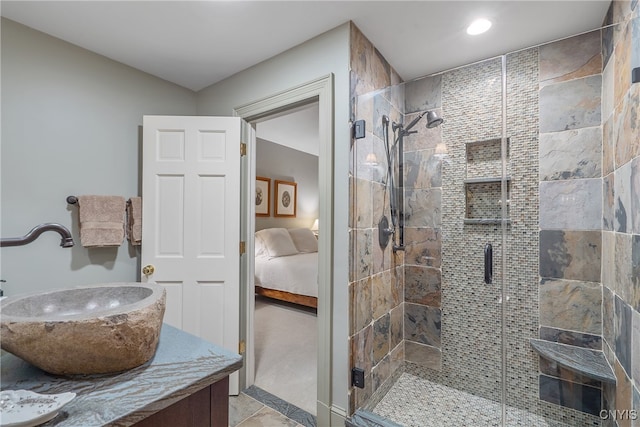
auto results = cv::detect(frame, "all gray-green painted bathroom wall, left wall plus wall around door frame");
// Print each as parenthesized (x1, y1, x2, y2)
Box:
(0, 19, 350, 418)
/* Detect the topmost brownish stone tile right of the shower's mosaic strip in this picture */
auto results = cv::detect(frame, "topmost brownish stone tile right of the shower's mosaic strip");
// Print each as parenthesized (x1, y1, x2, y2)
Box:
(540, 30, 602, 86)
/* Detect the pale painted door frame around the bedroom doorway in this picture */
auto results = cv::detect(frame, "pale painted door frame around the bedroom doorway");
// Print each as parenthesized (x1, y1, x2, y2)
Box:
(234, 74, 334, 425)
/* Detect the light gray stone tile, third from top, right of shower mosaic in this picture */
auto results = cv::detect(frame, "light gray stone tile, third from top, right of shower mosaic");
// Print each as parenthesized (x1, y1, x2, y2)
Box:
(540, 127, 602, 181)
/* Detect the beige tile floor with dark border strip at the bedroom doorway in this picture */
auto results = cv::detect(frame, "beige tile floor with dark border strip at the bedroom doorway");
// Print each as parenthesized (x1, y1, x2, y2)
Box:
(229, 386, 316, 427)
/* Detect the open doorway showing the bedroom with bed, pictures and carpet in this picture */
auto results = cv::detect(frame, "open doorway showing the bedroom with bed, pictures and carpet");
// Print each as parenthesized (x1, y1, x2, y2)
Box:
(249, 102, 320, 416)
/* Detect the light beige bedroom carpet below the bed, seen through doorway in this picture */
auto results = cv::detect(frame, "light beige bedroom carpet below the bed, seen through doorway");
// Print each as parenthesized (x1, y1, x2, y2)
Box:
(254, 297, 318, 415)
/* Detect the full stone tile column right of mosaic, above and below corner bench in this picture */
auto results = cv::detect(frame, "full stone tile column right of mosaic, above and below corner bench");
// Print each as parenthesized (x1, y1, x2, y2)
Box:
(538, 30, 603, 422)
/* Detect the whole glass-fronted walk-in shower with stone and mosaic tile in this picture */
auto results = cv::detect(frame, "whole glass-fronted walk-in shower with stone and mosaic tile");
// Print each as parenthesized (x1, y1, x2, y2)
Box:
(350, 2, 640, 426)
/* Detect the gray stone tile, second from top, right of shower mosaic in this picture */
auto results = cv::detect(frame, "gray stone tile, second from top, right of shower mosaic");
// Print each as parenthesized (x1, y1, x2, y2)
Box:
(540, 75, 602, 133)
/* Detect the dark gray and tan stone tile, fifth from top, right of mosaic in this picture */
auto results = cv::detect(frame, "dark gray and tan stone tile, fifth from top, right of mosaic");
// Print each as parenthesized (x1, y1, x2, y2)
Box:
(540, 230, 602, 282)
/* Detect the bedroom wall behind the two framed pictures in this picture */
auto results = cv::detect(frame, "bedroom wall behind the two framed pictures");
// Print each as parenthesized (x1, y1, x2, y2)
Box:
(256, 139, 319, 230)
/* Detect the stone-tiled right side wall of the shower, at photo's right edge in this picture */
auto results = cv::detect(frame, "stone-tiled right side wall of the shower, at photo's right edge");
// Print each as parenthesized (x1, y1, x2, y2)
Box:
(602, 1, 640, 427)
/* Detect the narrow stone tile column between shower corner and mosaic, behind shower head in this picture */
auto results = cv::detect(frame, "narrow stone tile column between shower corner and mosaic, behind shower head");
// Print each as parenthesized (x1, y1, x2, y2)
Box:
(403, 75, 445, 370)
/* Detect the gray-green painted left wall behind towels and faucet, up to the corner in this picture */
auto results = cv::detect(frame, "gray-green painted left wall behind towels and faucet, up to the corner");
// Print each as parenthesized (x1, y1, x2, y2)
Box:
(0, 18, 196, 295)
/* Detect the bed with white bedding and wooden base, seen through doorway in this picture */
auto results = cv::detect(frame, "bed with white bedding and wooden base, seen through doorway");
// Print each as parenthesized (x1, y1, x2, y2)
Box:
(255, 228, 318, 308)
